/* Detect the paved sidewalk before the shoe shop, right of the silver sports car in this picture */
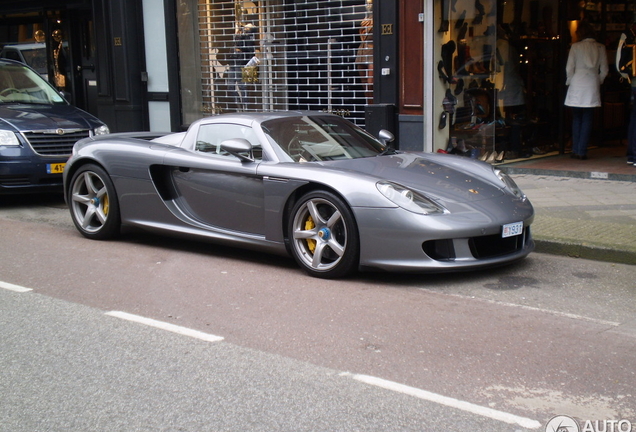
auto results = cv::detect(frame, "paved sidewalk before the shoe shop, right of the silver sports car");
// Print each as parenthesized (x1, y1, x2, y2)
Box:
(500, 149, 636, 265)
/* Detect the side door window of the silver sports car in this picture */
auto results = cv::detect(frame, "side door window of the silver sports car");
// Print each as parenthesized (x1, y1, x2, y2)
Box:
(196, 124, 263, 160)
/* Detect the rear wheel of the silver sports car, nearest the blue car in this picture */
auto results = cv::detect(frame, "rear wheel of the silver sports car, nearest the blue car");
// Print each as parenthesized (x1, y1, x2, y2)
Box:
(68, 165, 121, 240)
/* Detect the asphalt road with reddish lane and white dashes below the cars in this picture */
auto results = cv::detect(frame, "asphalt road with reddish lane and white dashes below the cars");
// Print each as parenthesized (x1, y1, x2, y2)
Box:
(0, 197, 636, 431)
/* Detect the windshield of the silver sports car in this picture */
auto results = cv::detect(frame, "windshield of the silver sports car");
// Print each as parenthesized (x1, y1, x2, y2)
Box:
(261, 115, 385, 162)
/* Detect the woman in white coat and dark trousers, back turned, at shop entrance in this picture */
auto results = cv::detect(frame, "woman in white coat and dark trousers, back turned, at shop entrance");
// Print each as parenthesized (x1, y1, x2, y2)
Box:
(565, 22, 608, 159)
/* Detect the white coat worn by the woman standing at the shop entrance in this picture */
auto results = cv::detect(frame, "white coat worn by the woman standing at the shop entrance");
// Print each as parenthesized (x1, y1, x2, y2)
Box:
(565, 38, 608, 108)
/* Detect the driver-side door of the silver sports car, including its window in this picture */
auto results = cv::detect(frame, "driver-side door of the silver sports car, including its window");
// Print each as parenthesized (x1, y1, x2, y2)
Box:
(165, 124, 265, 235)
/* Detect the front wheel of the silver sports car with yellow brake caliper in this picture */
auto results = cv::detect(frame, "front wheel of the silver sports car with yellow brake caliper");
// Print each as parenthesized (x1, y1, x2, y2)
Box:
(289, 191, 360, 278)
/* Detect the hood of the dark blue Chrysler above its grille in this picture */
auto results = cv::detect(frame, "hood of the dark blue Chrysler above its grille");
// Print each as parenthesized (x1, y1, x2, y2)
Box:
(0, 104, 102, 131)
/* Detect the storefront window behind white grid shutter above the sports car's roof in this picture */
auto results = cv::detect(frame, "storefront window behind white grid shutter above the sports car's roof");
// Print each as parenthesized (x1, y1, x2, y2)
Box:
(178, 0, 373, 125)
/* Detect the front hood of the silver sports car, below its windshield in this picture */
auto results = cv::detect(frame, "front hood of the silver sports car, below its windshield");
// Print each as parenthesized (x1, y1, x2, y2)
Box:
(324, 153, 504, 202)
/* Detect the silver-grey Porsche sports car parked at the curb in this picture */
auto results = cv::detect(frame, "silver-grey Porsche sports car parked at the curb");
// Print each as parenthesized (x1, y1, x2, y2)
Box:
(64, 112, 534, 278)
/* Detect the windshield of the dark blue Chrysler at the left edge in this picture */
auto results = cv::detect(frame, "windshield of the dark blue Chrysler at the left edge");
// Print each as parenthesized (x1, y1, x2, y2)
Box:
(0, 64, 65, 105)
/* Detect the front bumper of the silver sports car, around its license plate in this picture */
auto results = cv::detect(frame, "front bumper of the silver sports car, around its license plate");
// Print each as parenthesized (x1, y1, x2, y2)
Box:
(355, 202, 534, 273)
